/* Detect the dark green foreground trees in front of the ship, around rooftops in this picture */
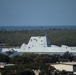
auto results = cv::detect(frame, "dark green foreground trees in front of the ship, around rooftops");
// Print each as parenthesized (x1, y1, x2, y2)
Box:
(0, 52, 76, 75)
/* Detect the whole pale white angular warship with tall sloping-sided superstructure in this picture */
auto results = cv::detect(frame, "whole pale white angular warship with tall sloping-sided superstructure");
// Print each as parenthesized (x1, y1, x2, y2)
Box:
(2, 36, 76, 53)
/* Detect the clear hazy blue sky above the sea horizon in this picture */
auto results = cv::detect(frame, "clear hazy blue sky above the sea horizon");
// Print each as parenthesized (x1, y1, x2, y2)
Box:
(0, 0, 76, 26)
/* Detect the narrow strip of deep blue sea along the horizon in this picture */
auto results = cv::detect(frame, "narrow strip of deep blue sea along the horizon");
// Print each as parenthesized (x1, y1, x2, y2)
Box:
(0, 26, 76, 30)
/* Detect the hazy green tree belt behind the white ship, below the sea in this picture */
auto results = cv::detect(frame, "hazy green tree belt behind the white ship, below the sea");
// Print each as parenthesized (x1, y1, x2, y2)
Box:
(0, 29, 76, 46)
